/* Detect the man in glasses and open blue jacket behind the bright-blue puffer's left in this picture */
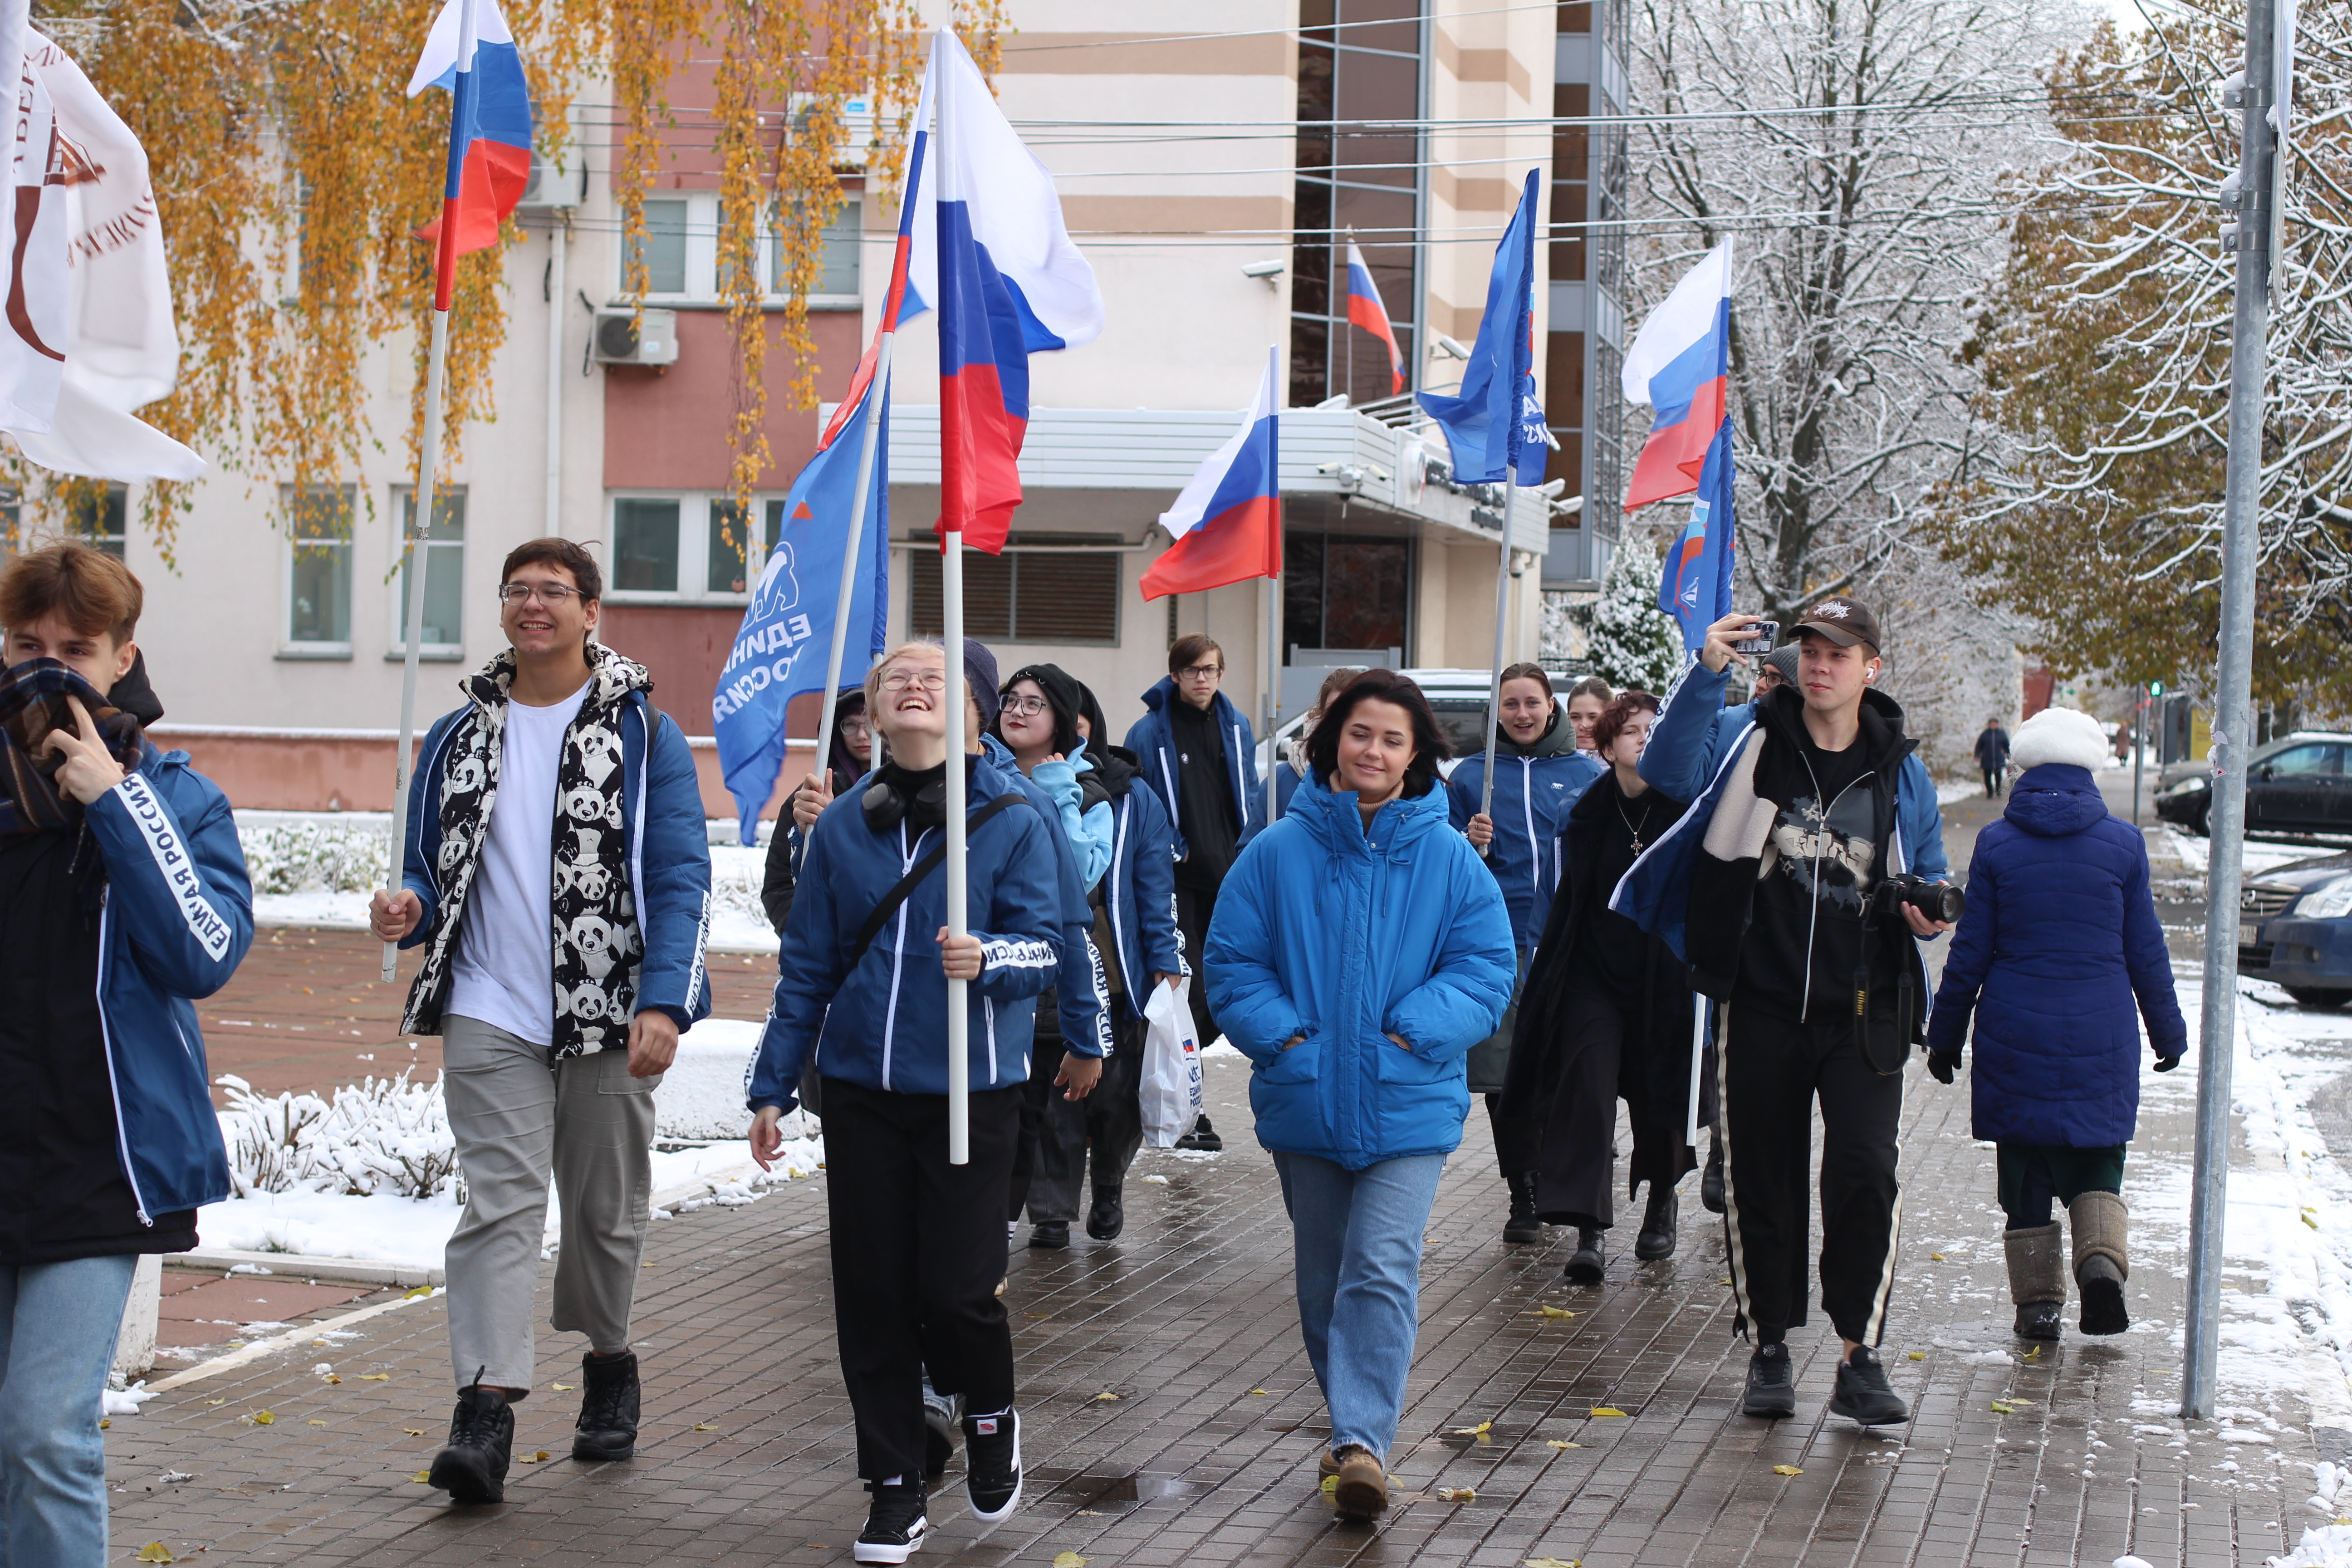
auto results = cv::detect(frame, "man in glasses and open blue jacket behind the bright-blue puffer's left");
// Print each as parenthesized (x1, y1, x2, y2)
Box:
(1127, 632, 1265, 1150)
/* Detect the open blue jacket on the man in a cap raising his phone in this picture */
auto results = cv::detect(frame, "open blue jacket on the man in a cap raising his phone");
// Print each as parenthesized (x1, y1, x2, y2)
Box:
(1609, 665, 1950, 973)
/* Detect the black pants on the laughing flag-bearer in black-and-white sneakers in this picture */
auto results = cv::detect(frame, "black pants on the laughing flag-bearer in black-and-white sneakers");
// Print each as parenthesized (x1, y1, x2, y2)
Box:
(823, 1079, 1021, 1481)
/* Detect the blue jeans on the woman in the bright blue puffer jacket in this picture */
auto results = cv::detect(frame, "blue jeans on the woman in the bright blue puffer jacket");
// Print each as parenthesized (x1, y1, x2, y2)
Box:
(1275, 1154, 1446, 1460)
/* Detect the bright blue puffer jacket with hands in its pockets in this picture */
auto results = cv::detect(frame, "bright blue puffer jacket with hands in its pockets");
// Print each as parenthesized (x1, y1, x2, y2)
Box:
(1202, 776, 1517, 1171)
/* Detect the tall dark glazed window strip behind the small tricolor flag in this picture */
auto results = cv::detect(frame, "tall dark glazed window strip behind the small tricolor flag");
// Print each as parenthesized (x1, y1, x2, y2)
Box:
(1291, 0, 1421, 407)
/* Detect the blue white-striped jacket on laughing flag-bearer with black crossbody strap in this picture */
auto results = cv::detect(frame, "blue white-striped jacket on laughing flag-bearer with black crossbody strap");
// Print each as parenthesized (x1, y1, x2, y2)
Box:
(745, 755, 1077, 1110)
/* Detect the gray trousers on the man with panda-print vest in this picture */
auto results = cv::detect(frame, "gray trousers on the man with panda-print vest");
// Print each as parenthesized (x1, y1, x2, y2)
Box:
(442, 1018, 661, 1389)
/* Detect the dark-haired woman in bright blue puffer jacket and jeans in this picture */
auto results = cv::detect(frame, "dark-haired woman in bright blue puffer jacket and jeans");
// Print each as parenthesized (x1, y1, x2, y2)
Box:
(1202, 670, 1514, 1519)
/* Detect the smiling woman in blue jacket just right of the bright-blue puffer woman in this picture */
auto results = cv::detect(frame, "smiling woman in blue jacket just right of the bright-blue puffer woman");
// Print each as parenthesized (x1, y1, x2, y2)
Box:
(1446, 663, 1602, 1241)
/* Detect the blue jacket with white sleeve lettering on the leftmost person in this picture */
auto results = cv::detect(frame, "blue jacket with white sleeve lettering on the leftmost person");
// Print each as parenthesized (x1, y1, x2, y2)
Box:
(85, 745, 254, 1225)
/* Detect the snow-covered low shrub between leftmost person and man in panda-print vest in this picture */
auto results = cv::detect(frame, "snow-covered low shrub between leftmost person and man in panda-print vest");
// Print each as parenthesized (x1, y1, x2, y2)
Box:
(214, 1070, 466, 1204)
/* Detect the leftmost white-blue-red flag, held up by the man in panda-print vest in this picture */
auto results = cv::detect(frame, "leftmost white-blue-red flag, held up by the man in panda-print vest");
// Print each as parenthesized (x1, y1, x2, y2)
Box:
(409, 0, 532, 310)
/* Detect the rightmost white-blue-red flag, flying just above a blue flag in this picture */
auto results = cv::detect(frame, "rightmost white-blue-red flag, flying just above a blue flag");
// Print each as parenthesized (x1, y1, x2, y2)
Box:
(1625, 240, 1731, 513)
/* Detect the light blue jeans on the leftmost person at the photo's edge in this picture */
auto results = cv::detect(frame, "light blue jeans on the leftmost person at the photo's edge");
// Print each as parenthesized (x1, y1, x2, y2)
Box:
(0, 1258, 139, 1568)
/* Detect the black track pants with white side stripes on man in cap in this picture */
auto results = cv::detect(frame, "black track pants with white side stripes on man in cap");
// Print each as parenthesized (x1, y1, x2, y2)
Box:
(1717, 1004, 1903, 1345)
